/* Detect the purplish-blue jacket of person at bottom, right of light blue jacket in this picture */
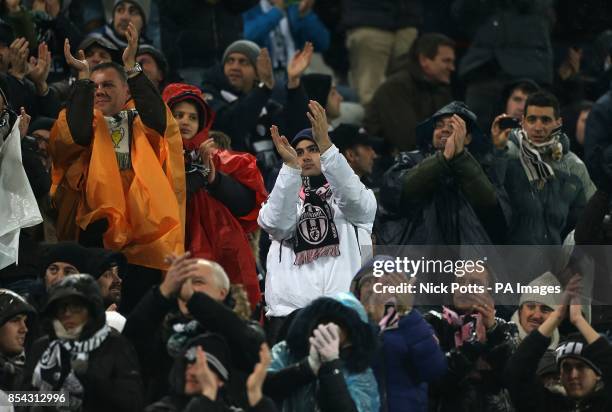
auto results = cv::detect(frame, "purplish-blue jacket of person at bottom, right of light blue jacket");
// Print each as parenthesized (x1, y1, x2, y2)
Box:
(374, 310, 447, 412)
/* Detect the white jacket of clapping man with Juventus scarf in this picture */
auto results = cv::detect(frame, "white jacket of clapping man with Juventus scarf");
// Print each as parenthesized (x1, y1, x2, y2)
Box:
(257, 146, 376, 316)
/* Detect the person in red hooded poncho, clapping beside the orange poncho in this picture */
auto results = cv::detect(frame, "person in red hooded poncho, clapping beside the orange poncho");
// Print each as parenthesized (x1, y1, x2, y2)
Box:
(163, 83, 267, 307)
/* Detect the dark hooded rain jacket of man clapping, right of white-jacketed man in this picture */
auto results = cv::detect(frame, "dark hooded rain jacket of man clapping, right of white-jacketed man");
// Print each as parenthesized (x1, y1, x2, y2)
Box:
(375, 103, 510, 245)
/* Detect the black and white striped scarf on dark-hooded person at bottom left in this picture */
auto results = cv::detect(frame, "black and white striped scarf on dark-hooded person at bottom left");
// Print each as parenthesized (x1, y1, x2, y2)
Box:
(32, 325, 111, 411)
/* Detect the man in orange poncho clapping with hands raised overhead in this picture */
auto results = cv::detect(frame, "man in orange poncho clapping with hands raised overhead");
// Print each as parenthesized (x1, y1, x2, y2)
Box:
(50, 24, 185, 312)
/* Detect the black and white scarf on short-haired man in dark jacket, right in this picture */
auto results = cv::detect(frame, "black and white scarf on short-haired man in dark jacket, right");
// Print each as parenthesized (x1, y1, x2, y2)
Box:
(517, 130, 563, 188)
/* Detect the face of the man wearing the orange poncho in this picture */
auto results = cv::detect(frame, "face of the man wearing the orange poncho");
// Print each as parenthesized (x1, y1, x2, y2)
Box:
(90, 68, 130, 116)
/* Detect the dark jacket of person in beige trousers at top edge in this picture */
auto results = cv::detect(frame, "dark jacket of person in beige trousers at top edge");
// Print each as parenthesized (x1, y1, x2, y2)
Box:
(342, 0, 423, 31)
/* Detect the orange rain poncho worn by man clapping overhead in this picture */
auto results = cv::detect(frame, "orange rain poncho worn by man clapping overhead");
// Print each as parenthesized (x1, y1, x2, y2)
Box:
(50, 101, 185, 270)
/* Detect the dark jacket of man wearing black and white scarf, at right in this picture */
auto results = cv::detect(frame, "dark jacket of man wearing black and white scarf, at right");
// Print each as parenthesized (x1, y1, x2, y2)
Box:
(504, 133, 595, 245)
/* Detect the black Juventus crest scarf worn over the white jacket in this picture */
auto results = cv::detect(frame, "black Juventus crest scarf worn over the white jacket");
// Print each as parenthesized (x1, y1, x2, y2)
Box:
(293, 175, 340, 266)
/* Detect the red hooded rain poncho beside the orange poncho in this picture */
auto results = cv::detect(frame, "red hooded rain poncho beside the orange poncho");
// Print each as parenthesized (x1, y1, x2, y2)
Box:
(163, 83, 268, 307)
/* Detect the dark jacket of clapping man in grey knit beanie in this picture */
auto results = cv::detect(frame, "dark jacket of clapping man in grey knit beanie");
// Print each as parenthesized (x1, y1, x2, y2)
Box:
(203, 65, 309, 170)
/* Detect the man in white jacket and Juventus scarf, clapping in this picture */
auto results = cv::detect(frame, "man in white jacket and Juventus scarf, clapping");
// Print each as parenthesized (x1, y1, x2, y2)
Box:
(257, 100, 376, 334)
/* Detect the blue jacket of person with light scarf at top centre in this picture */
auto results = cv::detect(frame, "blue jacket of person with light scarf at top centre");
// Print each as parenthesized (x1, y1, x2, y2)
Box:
(242, 4, 330, 57)
